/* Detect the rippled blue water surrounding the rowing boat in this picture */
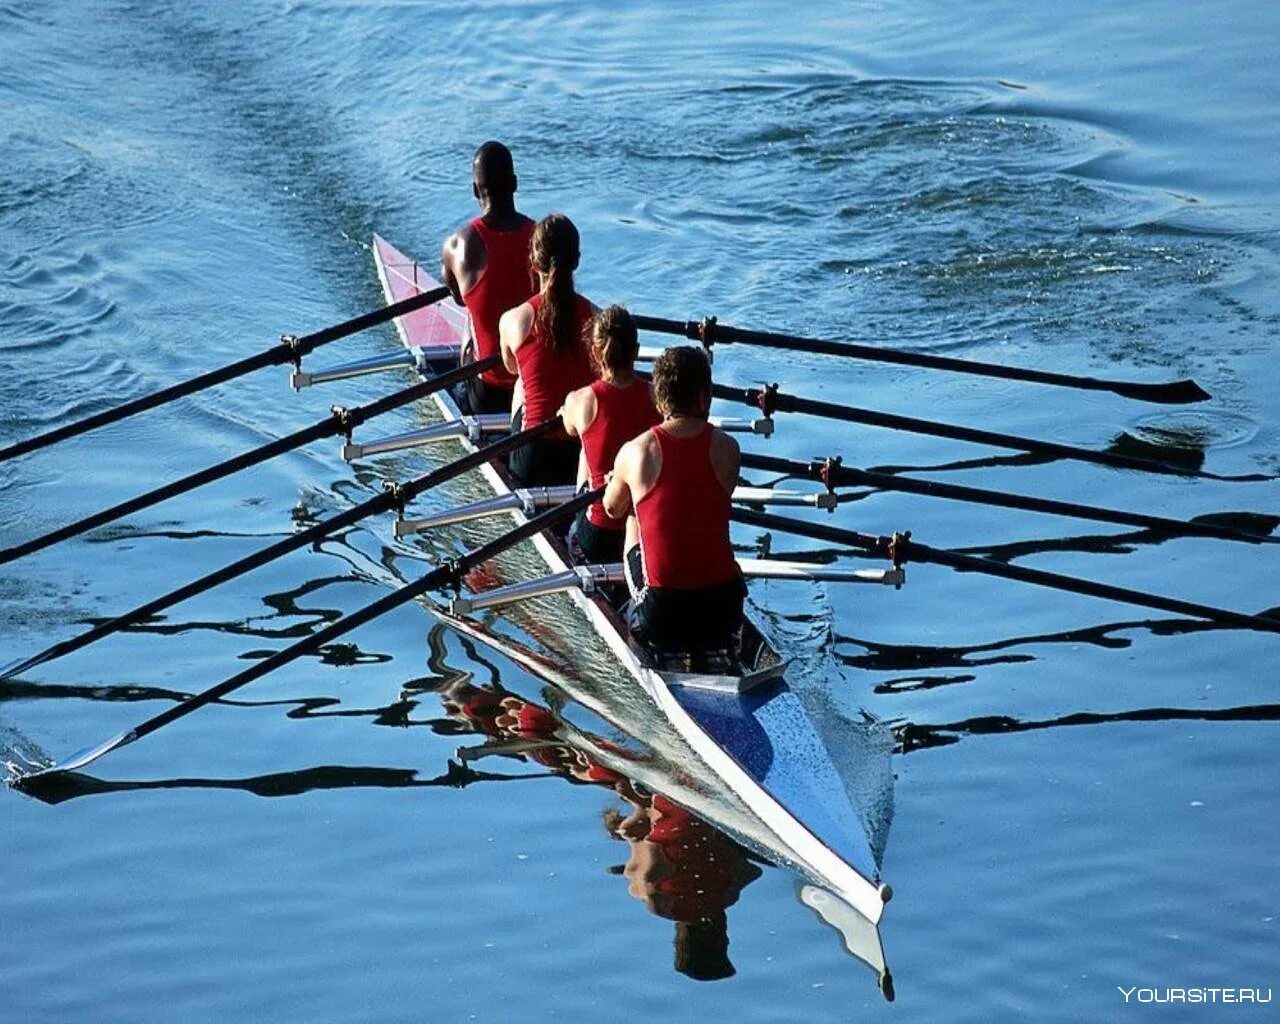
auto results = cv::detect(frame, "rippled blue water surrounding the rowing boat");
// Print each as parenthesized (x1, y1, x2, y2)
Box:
(0, 0, 1280, 1021)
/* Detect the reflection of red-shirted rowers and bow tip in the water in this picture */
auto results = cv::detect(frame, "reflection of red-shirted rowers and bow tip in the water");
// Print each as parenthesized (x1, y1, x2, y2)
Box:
(438, 677, 893, 1000)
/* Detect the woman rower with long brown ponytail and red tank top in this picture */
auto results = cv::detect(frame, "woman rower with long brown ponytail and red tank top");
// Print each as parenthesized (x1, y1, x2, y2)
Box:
(498, 214, 595, 488)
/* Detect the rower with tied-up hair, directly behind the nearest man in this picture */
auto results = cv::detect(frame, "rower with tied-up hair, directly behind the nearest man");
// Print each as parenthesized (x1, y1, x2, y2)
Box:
(563, 306, 662, 563)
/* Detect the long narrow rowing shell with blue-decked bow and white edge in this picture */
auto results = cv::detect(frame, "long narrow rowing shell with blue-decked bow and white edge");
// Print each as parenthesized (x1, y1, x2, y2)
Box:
(374, 236, 890, 936)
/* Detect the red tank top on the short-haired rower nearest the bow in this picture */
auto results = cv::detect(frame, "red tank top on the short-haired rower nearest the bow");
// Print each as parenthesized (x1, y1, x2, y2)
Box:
(636, 424, 737, 590)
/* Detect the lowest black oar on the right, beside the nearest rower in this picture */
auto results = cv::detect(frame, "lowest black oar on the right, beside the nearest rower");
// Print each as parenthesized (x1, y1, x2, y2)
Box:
(731, 508, 1280, 632)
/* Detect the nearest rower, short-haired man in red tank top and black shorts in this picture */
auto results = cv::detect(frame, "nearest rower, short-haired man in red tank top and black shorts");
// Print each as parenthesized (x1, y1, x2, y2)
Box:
(604, 346, 746, 654)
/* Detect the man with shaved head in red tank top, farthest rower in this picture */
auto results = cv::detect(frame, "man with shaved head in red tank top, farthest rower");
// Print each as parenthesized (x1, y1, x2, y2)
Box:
(440, 142, 534, 413)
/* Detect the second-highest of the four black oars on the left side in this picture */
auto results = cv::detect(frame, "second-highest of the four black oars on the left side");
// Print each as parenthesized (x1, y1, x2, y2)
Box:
(0, 356, 499, 566)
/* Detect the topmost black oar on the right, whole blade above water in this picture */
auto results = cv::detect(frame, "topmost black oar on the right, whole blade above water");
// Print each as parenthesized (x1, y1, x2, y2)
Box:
(632, 316, 1210, 404)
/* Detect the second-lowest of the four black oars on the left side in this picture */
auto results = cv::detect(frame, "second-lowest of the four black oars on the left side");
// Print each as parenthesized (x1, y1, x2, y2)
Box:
(0, 420, 559, 680)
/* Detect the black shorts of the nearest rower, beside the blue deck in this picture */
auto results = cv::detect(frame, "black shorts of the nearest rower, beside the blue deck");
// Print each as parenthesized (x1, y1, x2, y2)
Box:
(623, 544, 746, 650)
